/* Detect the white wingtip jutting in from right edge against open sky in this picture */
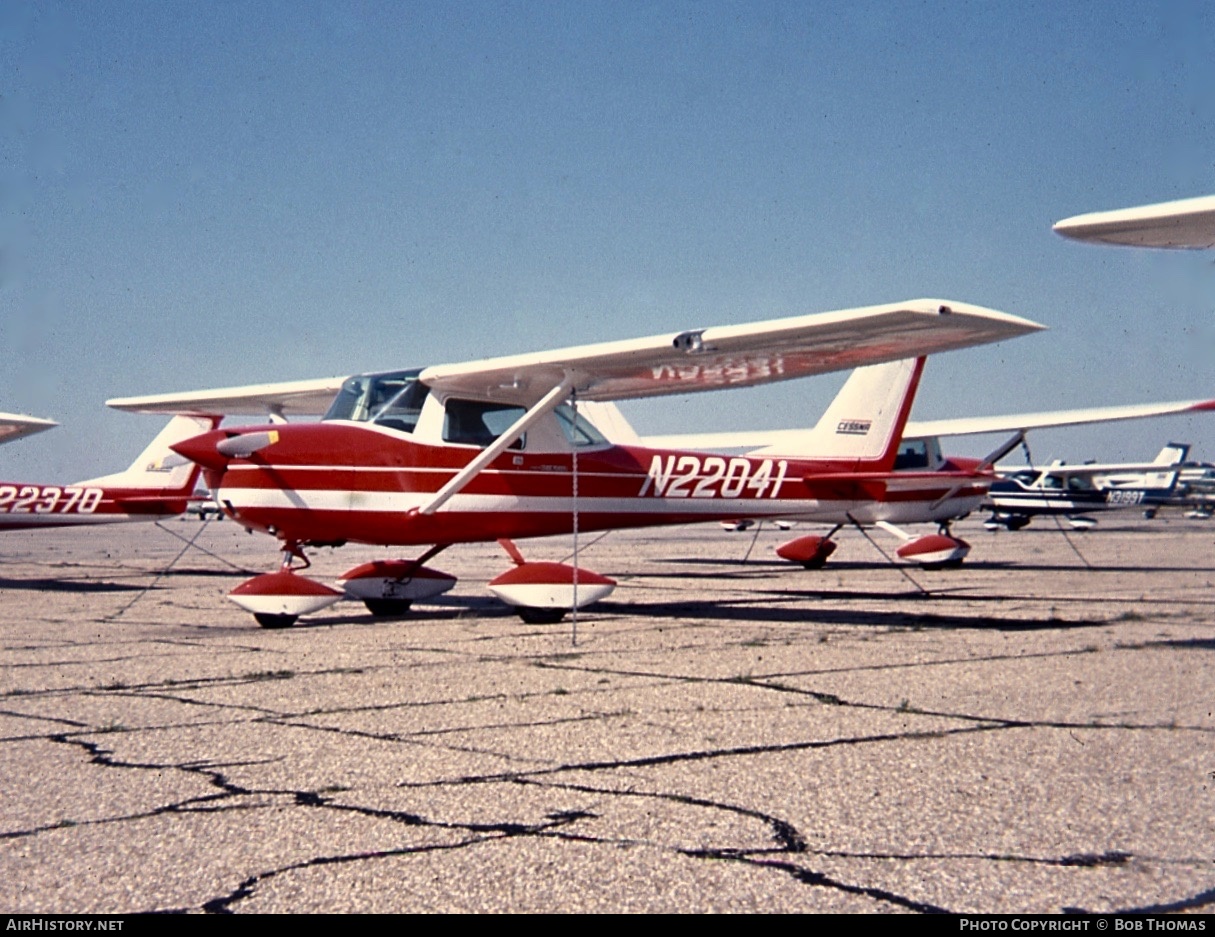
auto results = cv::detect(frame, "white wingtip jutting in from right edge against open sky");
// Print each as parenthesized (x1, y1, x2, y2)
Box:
(1053, 196, 1215, 250)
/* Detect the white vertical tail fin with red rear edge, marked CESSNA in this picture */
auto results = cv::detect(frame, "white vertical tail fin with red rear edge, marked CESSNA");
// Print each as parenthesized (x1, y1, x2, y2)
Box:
(761, 357, 925, 472)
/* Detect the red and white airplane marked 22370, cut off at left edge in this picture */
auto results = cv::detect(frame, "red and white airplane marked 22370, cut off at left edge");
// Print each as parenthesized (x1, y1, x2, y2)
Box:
(0, 413, 219, 530)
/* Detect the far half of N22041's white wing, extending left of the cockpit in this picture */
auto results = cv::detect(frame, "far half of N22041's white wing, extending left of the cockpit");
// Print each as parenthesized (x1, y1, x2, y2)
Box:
(106, 377, 346, 417)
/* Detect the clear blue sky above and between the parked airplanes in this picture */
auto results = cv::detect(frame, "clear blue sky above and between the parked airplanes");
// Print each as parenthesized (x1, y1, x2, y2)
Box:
(0, 2, 1215, 481)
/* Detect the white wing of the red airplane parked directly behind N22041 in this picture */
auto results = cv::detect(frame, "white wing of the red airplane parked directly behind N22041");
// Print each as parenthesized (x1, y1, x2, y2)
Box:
(643, 400, 1215, 451)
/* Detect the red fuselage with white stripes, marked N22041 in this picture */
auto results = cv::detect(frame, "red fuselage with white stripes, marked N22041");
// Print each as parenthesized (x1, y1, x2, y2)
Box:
(174, 420, 993, 546)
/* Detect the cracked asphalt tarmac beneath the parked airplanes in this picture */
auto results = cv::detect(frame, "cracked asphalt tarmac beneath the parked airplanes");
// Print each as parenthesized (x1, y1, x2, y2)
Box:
(0, 517, 1215, 913)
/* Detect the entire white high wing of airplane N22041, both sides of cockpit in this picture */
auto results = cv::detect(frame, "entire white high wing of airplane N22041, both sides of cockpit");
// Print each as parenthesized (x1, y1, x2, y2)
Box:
(107, 299, 1044, 416)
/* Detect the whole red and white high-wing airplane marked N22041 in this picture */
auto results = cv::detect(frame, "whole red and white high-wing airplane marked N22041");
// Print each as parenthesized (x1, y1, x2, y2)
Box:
(109, 300, 1041, 627)
